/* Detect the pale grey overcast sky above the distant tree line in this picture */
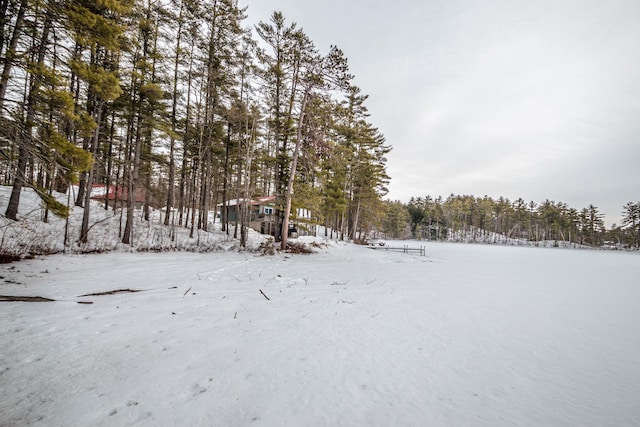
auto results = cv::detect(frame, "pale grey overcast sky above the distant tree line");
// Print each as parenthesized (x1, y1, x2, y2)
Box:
(240, 0, 640, 225)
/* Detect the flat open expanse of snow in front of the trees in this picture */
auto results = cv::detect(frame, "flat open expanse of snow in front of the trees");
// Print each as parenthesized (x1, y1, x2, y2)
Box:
(0, 242, 640, 426)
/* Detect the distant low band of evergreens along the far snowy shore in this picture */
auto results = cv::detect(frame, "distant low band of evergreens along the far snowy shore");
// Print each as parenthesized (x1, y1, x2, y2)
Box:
(383, 194, 640, 248)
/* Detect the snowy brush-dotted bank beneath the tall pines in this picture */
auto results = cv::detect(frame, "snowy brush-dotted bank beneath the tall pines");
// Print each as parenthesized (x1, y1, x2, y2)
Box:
(0, 186, 265, 257)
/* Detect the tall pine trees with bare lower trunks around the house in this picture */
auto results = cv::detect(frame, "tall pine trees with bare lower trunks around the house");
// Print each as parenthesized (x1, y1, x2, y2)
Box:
(0, 0, 391, 246)
